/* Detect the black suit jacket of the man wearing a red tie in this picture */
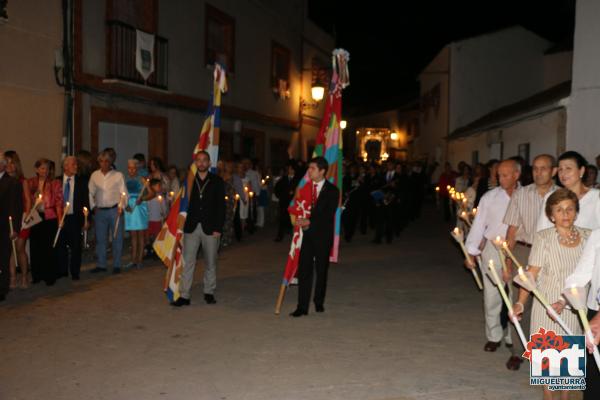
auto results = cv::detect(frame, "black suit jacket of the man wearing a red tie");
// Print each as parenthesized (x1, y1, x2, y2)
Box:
(303, 181, 340, 248)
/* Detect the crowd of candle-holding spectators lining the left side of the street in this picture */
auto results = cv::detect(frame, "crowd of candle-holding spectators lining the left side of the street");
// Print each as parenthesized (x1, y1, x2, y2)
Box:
(0, 148, 287, 300)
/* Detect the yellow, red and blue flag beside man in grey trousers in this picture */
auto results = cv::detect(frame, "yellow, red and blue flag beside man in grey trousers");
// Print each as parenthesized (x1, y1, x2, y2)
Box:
(153, 64, 227, 301)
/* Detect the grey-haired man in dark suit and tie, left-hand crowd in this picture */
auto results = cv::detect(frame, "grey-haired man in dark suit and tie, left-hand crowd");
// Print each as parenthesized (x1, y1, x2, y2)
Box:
(57, 156, 90, 281)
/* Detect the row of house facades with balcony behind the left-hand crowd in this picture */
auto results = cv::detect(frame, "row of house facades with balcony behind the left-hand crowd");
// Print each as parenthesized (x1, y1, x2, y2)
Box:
(0, 0, 334, 175)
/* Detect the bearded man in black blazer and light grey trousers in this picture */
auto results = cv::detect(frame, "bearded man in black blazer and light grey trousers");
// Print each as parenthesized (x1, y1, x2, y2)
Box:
(171, 151, 225, 307)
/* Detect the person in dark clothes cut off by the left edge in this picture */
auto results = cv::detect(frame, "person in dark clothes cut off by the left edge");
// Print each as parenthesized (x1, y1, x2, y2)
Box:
(0, 151, 23, 302)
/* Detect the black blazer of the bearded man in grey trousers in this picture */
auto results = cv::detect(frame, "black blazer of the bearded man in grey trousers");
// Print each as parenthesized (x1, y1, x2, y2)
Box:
(183, 173, 225, 235)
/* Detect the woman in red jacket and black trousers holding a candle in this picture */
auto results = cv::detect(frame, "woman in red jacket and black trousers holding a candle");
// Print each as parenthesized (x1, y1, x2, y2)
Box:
(27, 158, 63, 286)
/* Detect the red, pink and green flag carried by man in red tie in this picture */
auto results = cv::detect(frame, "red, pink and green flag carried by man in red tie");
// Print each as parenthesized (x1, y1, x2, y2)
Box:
(275, 49, 350, 314)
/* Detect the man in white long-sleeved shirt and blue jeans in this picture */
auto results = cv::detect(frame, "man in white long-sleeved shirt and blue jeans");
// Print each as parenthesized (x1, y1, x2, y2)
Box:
(88, 151, 127, 274)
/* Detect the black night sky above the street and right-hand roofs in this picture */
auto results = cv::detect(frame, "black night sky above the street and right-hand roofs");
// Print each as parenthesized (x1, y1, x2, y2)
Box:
(309, 0, 575, 115)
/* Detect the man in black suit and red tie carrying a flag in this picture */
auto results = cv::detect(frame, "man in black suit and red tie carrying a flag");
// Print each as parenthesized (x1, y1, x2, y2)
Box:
(290, 157, 340, 317)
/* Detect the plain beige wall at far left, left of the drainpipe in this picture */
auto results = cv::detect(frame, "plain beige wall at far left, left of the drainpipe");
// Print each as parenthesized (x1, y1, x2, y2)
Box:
(0, 0, 64, 177)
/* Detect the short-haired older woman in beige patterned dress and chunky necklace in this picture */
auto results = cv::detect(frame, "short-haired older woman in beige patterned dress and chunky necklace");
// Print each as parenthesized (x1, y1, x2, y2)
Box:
(513, 188, 591, 399)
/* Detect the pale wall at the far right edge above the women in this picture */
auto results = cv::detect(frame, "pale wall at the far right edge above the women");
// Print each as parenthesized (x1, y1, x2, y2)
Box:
(567, 0, 600, 161)
